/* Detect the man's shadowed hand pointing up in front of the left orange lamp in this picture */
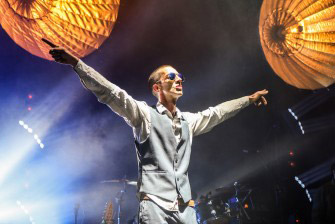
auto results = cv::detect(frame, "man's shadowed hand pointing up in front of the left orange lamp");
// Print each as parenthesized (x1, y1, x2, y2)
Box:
(42, 39, 79, 67)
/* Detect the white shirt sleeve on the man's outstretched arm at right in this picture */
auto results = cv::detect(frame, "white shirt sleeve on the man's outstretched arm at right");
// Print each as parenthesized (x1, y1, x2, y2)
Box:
(184, 96, 250, 136)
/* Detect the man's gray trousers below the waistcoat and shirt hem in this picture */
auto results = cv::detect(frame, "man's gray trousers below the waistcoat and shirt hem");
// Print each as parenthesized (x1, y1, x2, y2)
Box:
(138, 200, 197, 224)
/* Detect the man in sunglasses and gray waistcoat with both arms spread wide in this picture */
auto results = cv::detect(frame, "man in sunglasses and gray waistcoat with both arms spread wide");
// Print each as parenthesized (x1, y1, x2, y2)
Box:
(46, 41, 268, 224)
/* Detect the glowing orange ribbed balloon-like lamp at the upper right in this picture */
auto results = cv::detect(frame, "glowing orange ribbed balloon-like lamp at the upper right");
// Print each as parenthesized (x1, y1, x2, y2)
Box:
(259, 0, 335, 90)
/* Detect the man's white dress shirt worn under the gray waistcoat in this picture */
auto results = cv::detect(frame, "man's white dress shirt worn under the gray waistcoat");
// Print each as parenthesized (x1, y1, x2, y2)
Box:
(74, 60, 250, 211)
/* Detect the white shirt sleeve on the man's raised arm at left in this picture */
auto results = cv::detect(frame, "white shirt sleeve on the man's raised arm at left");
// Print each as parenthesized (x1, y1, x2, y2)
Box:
(74, 60, 150, 140)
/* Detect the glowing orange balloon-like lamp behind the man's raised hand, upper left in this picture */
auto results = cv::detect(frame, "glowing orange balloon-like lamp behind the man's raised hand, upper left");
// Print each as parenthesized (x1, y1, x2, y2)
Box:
(0, 0, 120, 60)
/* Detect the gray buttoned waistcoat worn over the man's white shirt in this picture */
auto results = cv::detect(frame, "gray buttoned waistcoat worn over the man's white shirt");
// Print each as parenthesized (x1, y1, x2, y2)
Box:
(135, 107, 191, 202)
